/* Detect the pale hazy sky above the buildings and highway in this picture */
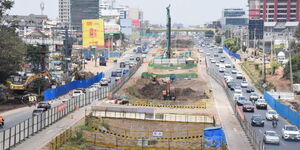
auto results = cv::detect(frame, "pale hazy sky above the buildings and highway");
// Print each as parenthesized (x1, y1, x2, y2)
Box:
(10, 0, 248, 25)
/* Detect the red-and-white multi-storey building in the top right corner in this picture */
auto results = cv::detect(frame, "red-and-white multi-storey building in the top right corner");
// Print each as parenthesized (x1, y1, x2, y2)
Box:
(248, 0, 300, 22)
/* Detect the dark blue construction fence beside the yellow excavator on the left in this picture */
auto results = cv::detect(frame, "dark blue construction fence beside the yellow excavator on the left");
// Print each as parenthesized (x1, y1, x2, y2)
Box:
(44, 72, 103, 101)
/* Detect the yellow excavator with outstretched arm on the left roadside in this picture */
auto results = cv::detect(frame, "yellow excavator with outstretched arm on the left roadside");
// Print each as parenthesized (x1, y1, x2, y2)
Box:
(7, 71, 52, 91)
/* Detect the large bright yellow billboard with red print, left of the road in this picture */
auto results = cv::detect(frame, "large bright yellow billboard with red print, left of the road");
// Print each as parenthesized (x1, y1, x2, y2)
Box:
(82, 19, 104, 46)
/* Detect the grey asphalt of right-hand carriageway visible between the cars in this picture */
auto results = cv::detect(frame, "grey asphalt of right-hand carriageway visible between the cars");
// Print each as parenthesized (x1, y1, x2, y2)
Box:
(202, 42, 300, 150)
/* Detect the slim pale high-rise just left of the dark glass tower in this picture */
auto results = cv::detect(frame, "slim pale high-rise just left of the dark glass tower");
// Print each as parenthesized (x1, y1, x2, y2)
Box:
(58, 0, 71, 26)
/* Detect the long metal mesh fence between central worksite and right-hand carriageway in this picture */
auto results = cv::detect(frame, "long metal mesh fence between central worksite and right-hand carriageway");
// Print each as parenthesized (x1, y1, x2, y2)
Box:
(205, 59, 266, 150)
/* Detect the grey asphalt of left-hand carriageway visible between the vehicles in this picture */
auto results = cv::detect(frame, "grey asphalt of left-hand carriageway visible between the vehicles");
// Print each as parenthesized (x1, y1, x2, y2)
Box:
(0, 47, 145, 131)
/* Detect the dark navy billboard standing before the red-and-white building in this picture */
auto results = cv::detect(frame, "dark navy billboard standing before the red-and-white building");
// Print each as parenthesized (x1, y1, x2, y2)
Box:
(249, 20, 264, 40)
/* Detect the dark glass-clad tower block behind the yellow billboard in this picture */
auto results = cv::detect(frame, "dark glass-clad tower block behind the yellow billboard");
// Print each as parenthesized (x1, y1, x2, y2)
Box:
(70, 0, 99, 31)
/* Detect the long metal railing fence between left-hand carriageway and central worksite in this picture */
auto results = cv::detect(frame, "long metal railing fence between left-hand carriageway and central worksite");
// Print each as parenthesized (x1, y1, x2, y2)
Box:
(0, 60, 143, 150)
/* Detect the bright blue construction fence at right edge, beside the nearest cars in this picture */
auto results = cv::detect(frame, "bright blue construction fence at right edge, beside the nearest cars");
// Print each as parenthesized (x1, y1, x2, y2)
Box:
(264, 91, 300, 128)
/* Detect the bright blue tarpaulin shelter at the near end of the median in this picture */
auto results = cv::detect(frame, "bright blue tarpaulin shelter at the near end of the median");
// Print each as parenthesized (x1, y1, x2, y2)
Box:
(204, 127, 226, 148)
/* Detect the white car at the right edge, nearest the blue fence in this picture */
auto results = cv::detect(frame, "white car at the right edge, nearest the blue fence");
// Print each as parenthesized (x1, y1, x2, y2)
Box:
(281, 125, 300, 140)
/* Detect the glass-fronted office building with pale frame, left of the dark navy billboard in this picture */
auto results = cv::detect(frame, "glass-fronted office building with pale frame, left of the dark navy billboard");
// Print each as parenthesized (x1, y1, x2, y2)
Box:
(221, 8, 248, 26)
